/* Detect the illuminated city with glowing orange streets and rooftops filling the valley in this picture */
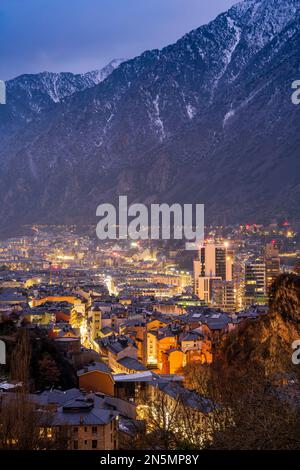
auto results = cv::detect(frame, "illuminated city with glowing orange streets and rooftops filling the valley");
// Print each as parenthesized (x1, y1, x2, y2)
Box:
(0, 222, 300, 450)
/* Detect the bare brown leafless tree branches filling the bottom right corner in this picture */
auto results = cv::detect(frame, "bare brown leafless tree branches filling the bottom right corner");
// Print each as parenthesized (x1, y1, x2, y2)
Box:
(186, 364, 300, 450)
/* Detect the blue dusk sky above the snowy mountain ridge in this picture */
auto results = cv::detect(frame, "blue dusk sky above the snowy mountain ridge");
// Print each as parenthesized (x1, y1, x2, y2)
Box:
(0, 0, 237, 80)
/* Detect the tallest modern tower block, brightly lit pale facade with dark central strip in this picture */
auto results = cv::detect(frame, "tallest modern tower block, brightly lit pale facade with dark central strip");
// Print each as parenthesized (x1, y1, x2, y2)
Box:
(194, 244, 233, 304)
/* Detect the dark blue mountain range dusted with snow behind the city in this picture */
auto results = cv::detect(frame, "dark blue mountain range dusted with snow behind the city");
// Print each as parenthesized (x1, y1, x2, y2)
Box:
(0, 0, 300, 235)
